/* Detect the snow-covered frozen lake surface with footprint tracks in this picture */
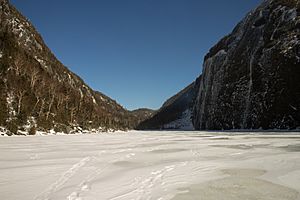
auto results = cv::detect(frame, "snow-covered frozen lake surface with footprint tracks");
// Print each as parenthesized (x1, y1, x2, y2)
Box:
(0, 132, 300, 200)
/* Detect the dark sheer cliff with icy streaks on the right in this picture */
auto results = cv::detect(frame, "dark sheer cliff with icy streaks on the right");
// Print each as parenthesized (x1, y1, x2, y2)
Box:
(193, 0, 300, 129)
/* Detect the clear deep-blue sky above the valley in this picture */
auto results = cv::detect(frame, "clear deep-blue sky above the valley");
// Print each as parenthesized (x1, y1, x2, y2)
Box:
(11, 0, 261, 109)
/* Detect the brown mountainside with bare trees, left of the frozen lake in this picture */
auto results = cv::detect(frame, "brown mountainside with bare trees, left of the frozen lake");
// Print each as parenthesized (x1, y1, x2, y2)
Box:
(0, 0, 147, 134)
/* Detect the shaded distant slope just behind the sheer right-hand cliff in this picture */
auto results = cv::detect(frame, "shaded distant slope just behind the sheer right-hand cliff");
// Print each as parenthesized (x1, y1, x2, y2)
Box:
(138, 77, 201, 130)
